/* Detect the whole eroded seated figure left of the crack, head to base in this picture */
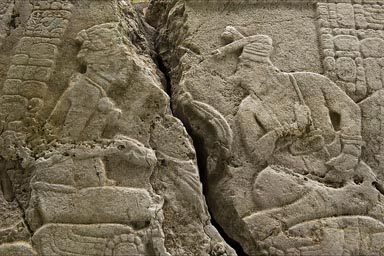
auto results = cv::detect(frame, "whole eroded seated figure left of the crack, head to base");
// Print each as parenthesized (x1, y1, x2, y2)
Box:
(26, 23, 169, 256)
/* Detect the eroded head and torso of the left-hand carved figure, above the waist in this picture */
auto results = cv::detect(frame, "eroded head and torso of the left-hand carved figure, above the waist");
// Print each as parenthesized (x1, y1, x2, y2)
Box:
(48, 23, 128, 140)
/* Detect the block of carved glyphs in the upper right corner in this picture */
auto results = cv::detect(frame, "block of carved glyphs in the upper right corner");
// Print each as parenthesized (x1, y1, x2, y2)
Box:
(317, 1, 383, 101)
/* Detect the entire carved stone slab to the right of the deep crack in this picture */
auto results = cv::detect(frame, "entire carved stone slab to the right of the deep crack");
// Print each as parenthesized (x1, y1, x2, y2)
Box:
(147, 0, 384, 255)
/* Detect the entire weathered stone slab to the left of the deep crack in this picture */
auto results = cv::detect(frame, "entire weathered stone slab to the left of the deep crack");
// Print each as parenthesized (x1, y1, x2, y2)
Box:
(0, 0, 235, 256)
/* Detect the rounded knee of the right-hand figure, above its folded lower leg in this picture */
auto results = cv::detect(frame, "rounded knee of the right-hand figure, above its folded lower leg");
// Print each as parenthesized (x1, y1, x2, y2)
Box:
(253, 166, 306, 209)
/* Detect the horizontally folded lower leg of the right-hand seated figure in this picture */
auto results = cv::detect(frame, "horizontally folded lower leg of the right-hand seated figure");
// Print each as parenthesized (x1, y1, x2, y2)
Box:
(244, 176, 378, 240)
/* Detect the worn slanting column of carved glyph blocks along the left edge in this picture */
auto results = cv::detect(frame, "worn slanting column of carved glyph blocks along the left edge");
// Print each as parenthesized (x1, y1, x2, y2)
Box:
(0, 1, 72, 255)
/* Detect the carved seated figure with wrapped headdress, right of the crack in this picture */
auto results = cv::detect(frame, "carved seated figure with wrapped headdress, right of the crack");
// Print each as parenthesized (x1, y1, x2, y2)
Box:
(213, 27, 384, 255)
